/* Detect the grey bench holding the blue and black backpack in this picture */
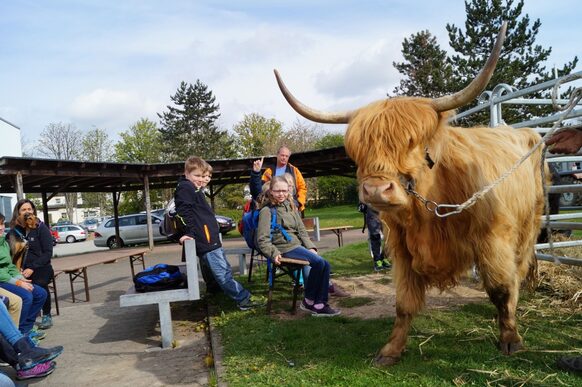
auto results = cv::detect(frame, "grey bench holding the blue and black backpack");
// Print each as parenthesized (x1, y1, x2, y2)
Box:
(119, 240, 200, 348)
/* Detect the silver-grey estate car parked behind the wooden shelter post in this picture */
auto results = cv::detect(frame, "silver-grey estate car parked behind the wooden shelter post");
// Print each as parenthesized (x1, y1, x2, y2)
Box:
(93, 214, 166, 249)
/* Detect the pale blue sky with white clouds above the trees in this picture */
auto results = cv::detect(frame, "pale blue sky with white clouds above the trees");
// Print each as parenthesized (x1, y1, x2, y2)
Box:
(0, 0, 582, 153)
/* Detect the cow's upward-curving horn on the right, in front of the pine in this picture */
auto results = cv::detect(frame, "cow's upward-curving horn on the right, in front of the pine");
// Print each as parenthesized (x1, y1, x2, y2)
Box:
(432, 22, 507, 112)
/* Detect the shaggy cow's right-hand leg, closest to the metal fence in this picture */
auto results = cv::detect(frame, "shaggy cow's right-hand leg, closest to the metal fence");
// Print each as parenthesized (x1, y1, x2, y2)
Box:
(479, 245, 523, 355)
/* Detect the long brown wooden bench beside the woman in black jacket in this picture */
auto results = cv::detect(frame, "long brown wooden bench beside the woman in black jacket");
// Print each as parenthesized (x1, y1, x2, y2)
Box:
(50, 248, 149, 315)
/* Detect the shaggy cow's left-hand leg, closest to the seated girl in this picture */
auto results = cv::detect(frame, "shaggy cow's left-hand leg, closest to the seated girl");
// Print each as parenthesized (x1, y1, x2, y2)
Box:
(375, 257, 426, 366)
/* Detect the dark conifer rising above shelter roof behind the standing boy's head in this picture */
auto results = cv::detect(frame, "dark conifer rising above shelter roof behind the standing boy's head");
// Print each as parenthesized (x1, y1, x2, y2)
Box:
(158, 80, 232, 161)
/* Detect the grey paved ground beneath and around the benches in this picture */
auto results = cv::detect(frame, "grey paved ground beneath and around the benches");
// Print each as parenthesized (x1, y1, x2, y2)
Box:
(2, 230, 365, 387)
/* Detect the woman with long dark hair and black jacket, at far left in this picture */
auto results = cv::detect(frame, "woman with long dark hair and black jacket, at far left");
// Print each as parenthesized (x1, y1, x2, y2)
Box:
(10, 199, 54, 330)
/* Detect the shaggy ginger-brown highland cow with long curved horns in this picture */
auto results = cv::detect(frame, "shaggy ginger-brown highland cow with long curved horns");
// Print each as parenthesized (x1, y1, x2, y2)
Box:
(275, 25, 549, 365)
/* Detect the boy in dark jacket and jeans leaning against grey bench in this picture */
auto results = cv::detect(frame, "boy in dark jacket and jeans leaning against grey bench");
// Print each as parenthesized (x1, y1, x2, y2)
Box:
(174, 156, 264, 310)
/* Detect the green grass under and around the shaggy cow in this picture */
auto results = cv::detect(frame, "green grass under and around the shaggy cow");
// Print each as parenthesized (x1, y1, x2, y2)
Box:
(214, 243, 582, 387)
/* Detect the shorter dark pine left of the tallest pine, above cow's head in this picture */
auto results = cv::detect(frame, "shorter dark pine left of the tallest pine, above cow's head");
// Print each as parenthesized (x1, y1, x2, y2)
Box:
(392, 30, 452, 98)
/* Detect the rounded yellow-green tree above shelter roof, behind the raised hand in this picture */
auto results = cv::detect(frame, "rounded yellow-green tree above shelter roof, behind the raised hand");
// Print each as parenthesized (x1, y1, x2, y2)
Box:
(232, 113, 283, 157)
